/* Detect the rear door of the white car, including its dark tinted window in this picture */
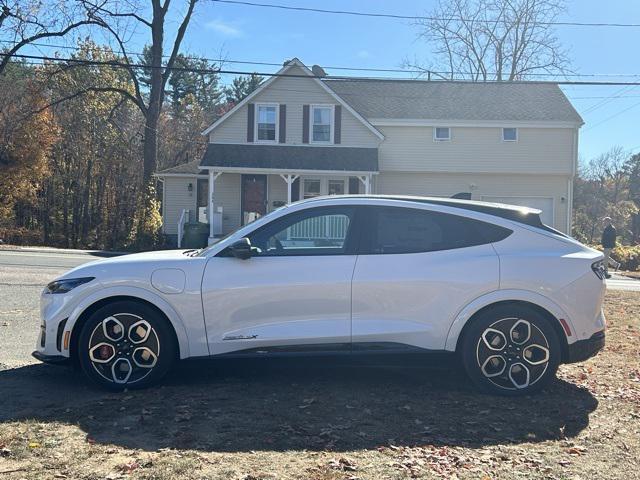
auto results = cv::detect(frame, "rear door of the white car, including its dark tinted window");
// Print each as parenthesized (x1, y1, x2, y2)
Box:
(352, 207, 502, 351)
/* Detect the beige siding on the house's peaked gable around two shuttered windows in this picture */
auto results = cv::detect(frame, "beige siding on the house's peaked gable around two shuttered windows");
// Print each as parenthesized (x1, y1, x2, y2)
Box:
(209, 67, 380, 147)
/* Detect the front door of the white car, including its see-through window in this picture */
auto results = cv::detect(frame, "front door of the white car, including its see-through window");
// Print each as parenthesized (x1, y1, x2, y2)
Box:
(202, 206, 357, 355)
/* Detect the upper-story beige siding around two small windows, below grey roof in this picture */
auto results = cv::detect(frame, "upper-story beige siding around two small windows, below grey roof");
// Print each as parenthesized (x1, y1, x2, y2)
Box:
(379, 126, 575, 175)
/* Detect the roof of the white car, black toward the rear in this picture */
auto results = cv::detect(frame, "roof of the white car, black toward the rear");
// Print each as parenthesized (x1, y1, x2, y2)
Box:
(298, 195, 560, 234)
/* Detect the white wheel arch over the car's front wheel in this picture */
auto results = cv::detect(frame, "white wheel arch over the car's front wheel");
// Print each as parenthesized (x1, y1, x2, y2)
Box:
(65, 289, 189, 361)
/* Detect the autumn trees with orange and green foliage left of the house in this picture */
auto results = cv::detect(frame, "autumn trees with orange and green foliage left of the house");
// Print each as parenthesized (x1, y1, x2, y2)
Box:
(0, 40, 257, 250)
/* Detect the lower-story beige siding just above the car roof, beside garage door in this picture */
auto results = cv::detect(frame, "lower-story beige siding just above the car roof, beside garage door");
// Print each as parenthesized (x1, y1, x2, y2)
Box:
(375, 172, 569, 232)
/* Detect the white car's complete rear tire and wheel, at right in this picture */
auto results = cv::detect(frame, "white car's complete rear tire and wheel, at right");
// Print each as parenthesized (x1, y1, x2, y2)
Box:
(460, 305, 562, 396)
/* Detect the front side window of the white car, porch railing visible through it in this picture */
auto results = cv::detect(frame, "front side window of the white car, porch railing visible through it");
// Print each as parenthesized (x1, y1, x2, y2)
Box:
(249, 207, 355, 257)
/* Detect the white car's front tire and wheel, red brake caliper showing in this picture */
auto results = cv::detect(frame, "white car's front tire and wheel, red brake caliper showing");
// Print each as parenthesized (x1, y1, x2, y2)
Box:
(77, 300, 177, 391)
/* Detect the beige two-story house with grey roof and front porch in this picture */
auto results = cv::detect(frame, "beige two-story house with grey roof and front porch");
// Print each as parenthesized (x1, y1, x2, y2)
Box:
(158, 59, 583, 244)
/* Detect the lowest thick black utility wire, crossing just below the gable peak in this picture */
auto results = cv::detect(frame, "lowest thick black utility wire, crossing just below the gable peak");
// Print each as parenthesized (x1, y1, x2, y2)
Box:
(6, 53, 640, 86)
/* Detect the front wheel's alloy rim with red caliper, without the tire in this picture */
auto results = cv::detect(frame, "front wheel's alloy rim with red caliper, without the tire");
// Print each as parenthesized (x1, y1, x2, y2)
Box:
(88, 313, 160, 385)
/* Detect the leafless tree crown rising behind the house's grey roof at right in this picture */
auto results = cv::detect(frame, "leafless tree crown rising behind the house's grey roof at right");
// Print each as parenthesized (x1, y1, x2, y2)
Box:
(412, 0, 569, 81)
